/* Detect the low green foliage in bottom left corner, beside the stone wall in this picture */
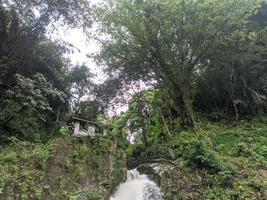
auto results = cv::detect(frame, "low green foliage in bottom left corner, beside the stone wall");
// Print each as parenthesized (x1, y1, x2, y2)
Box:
(0, 138, 51, 200)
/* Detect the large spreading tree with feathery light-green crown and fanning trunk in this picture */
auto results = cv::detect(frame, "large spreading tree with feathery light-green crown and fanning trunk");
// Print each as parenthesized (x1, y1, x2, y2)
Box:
(96, 0, 260, 128)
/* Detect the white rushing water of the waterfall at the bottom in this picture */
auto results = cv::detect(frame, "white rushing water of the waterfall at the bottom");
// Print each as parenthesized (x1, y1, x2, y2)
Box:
(110, 169, 163, 200)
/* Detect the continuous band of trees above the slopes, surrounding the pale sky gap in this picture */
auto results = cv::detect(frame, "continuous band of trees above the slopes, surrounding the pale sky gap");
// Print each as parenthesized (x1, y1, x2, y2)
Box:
(0, 0, 267, 142)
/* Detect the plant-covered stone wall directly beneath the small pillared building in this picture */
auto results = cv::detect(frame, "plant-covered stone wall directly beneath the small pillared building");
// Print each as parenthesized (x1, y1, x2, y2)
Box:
(42, 137, 127, 200)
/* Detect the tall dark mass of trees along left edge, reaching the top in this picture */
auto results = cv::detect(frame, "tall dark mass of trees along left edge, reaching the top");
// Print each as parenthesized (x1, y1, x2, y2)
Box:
(0, 0, 91, 142)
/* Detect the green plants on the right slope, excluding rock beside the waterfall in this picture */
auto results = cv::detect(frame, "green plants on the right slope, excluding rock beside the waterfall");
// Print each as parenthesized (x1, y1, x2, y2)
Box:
(128, 121, 267, 199)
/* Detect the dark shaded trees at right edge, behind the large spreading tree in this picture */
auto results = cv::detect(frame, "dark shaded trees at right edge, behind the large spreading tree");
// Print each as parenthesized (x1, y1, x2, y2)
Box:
(194, 4, 267, 120)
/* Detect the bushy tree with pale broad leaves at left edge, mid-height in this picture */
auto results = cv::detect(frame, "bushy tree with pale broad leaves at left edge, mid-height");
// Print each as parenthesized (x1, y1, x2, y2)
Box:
(0, 73, 66, 140)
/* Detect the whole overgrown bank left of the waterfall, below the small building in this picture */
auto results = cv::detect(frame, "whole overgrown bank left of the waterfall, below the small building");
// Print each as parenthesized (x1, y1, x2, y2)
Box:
(0, 137, 126, 200)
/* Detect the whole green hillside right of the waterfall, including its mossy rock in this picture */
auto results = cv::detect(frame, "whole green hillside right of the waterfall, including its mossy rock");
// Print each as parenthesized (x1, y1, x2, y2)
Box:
(128, 121, 267, 200)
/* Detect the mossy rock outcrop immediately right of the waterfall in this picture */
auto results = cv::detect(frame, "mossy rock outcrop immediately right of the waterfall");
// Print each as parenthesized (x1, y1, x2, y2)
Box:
(137, 160, 201, 200)
